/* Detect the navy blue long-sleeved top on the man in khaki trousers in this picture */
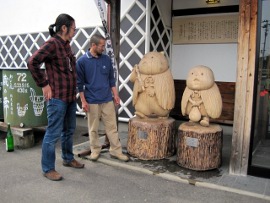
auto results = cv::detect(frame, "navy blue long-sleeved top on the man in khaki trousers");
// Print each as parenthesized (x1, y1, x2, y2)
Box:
(76, 51, 115, 104)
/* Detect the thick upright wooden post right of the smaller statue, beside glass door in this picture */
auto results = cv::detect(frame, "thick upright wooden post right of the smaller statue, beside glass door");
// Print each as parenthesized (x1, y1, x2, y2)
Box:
(230, 0, 258, 175)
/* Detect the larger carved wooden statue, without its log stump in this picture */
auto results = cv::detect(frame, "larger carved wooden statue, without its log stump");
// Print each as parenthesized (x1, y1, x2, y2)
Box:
(130, 52, 175, 118)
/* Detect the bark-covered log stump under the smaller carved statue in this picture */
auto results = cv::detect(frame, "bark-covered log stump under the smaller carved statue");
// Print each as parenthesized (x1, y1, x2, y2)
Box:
(176, 122, 223, 171)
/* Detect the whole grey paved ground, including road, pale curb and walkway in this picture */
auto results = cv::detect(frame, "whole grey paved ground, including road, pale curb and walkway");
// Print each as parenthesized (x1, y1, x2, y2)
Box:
(0, 118, 270, 203)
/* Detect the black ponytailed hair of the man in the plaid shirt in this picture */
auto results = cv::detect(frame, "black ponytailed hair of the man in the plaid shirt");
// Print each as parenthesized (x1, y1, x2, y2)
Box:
(49, 13, 75, 37)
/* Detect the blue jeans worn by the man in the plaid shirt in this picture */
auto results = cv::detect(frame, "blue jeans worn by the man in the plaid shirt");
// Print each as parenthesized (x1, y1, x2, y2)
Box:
(41, 98, 76, 173)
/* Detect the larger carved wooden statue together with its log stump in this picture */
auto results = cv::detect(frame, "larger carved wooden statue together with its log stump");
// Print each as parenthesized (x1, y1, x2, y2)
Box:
(127, 52, 175, 160)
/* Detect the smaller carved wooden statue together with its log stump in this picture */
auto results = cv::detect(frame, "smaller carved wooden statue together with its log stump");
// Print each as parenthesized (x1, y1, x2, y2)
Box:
(176, 65, 223, 171)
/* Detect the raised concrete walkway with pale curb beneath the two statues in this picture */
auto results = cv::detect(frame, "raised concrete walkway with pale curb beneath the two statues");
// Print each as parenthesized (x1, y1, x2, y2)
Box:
(74, 120, 270, 201)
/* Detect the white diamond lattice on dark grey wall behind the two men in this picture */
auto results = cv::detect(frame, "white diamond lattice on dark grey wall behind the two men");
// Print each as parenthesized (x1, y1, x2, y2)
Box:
(0, 0, 171, 122)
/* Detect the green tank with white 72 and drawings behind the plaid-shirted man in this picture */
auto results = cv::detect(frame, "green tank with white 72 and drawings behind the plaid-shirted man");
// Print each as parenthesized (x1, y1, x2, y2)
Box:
(2, 69, 47, 127)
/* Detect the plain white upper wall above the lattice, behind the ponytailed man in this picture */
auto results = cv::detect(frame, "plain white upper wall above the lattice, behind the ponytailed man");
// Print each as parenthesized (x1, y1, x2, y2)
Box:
(0, 0, 135, 36)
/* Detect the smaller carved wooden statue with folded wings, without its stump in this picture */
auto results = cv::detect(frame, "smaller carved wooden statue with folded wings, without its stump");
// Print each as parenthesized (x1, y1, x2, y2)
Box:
(181, 65, 222, 126)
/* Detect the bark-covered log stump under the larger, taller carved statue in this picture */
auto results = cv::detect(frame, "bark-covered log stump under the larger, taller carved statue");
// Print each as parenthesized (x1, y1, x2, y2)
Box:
(127, 117, 175, 160)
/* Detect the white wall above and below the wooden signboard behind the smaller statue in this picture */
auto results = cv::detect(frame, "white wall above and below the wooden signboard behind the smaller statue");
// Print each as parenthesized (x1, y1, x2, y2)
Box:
(171, 0, 239, 82)
